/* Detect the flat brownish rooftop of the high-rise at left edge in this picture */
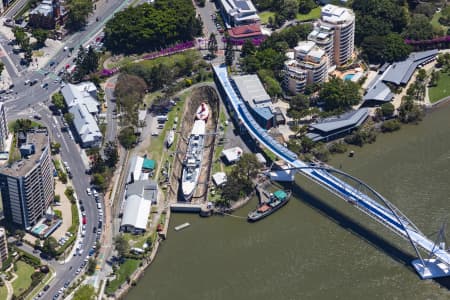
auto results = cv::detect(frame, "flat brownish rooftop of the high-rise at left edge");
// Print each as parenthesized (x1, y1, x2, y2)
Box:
(0, 129, 49, 177)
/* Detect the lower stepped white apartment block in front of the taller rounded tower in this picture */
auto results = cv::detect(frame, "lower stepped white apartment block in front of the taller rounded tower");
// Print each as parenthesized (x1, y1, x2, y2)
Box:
(283, 41, 328, 94)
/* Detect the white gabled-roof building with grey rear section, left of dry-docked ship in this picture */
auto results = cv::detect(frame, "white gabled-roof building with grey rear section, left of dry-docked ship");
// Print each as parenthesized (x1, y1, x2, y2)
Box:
(120, 180, 158, 233)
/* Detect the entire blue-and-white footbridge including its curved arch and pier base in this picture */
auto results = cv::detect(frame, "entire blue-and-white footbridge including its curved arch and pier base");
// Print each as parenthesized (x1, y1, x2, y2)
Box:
(213, 66, 450, 279)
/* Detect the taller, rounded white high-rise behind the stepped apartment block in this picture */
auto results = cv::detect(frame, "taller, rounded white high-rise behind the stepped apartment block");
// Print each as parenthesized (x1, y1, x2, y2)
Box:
(308, 4, 355, 66)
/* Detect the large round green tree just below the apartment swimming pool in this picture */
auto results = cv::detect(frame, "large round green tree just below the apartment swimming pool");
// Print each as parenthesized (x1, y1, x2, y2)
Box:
(319, 78, 362, 111)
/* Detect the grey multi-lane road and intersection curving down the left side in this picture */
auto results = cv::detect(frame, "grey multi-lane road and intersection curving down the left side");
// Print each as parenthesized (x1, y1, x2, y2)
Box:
(0, 0, 129, 299)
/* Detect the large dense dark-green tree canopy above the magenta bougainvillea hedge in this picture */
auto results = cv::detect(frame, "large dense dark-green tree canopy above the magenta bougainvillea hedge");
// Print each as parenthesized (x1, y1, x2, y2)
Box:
(105, 0, 201, 53)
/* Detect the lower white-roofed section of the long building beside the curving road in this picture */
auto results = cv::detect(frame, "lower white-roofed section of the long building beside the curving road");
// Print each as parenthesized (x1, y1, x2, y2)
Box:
(69, 104, 103, 148)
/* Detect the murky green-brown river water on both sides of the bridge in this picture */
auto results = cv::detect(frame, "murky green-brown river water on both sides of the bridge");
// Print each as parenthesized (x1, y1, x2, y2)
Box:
(126, 105, 450, 300)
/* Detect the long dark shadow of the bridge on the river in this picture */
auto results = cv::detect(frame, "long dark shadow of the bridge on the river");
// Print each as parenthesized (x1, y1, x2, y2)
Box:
(281, 179, 450, 290)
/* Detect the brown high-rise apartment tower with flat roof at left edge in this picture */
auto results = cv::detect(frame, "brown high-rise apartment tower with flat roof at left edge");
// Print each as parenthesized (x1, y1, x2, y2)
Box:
(0, 129, 54, 229)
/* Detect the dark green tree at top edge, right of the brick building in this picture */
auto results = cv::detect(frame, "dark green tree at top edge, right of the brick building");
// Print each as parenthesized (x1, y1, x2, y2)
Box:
(65, 0, 94, 31)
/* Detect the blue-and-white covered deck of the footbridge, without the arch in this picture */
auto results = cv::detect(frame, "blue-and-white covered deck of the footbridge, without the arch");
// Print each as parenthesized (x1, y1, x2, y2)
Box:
(214, 66, 450, 266)
